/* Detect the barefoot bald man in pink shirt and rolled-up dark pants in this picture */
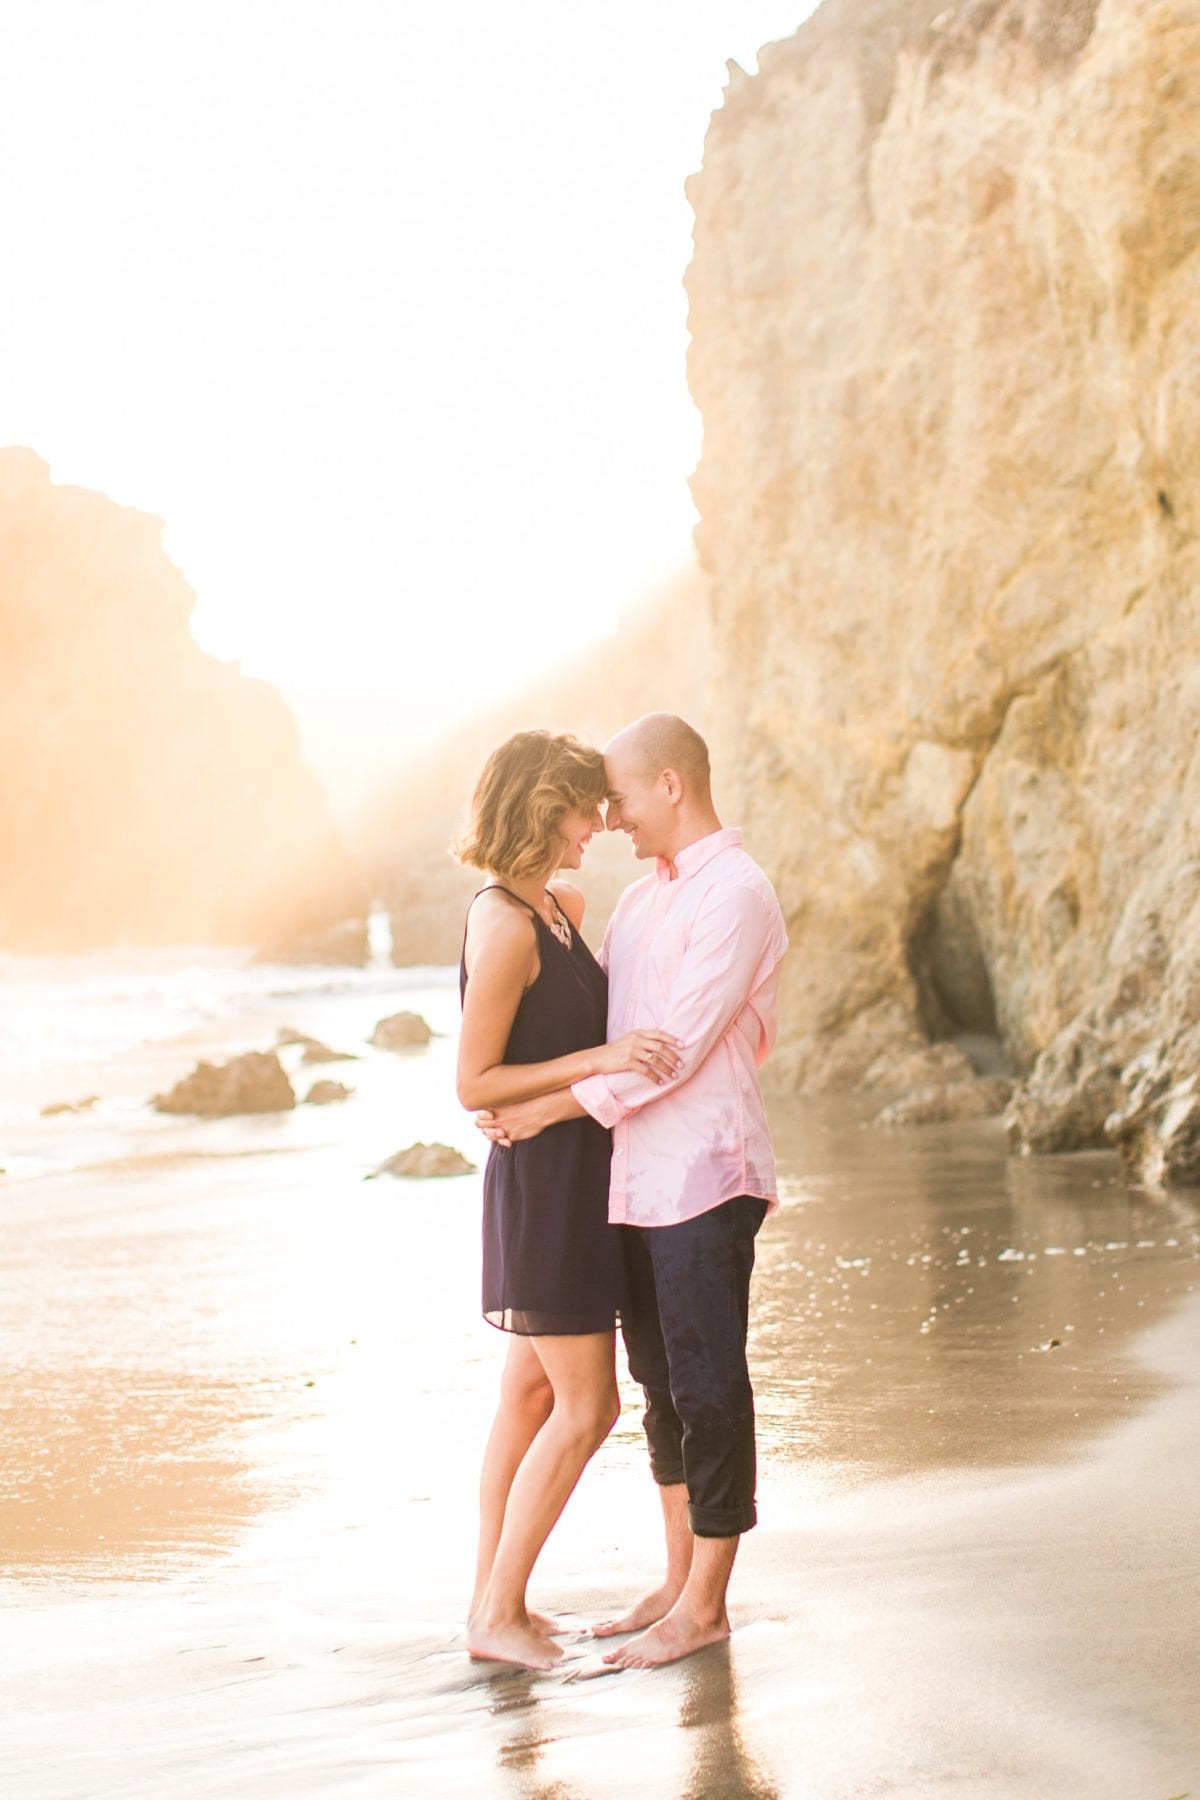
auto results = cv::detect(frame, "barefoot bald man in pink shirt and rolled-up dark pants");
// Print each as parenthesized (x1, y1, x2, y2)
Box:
(479, 713, 788, 1669)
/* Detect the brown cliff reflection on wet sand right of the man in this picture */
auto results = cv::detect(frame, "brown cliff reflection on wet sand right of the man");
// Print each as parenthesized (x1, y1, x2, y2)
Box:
(752, 1102, 1200, 1474)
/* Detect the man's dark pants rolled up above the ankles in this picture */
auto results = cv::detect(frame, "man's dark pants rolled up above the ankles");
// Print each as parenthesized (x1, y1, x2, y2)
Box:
(622, 1193, 766, 1537)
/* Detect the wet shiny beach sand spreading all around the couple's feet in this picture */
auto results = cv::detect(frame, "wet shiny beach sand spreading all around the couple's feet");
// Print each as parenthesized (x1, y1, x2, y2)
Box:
(0, 990, 1200, 1800)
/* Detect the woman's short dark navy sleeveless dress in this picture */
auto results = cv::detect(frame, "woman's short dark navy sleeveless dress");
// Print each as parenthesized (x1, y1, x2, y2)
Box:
(459, 884, 626, 1337)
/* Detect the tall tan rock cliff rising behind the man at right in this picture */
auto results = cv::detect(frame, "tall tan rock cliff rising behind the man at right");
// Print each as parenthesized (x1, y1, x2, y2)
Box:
(687, 0, 1200, 1181)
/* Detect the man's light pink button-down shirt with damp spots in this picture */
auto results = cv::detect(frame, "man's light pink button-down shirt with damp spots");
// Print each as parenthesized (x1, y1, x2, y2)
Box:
(572, 830, 788, 1226)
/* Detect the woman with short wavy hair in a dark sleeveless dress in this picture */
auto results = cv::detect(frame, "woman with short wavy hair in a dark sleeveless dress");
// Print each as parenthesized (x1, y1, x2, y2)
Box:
(459, 731, 678, 1669)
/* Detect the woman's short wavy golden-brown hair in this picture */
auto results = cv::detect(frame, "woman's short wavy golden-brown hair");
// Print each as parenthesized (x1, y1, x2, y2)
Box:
(455, 731, 606, 880)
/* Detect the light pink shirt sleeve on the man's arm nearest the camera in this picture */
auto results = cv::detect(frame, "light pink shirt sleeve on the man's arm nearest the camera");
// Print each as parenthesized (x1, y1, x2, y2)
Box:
(570, 887, 774, 1130)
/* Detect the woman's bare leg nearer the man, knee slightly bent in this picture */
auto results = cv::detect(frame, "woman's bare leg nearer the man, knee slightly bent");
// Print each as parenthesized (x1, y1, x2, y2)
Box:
(466, 1332, 621, 1669)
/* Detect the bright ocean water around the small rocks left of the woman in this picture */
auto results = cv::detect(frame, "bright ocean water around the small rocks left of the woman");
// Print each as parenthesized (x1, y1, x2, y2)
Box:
(0, 918, 462, 1179)
